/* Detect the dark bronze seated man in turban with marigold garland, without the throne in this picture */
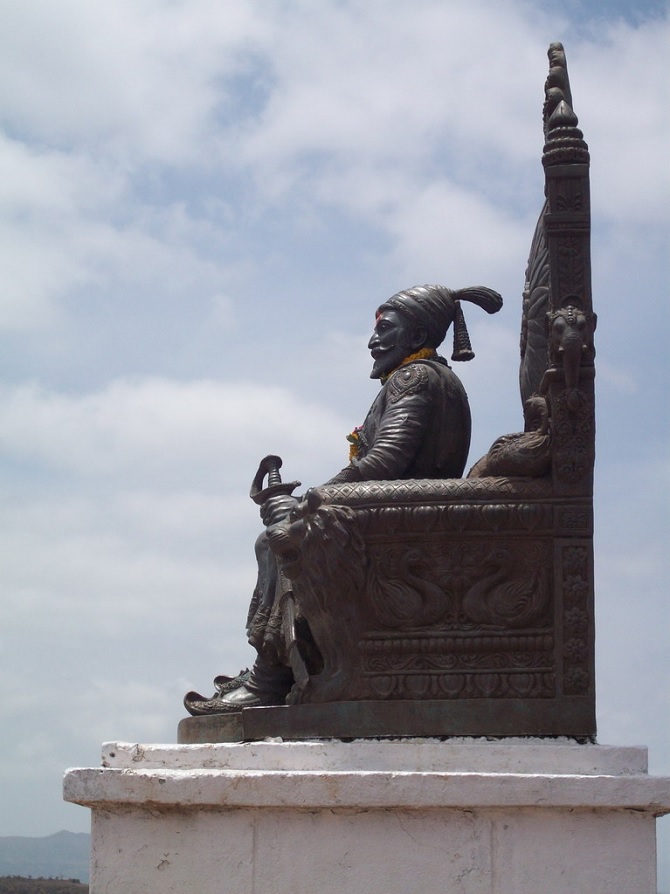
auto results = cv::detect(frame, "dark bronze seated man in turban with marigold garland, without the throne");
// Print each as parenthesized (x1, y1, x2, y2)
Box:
(184, 286, 502, 715)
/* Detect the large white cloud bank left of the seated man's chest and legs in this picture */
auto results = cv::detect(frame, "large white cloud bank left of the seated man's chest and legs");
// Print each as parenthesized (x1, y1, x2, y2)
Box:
(0, 379, 354, 762)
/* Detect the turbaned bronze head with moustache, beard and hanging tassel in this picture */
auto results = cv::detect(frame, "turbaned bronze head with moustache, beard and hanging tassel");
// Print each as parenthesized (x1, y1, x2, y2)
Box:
(368, 286, 502, 379)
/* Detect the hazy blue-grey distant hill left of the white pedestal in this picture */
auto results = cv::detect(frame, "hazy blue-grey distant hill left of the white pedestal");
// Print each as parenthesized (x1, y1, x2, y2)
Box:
(0, 832, 91, 894)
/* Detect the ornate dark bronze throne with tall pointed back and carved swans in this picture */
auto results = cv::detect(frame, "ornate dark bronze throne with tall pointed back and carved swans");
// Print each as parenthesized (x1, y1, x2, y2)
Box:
(243, 44, 595, 738)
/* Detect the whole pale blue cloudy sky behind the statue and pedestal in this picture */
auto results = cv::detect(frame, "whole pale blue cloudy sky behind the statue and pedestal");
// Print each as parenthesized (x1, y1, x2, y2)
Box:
(0, 0, 670, 890)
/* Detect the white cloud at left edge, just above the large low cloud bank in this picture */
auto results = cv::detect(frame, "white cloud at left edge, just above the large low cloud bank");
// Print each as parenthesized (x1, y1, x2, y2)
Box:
(0, 137, 243, 330)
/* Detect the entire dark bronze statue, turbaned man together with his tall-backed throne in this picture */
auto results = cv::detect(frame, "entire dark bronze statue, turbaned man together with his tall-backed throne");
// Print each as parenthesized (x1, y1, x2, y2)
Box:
(180, 44, 596, 742)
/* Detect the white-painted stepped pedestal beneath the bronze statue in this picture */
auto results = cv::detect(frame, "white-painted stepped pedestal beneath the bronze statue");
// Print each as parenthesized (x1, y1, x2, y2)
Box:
(64, 739, 670, 894)
